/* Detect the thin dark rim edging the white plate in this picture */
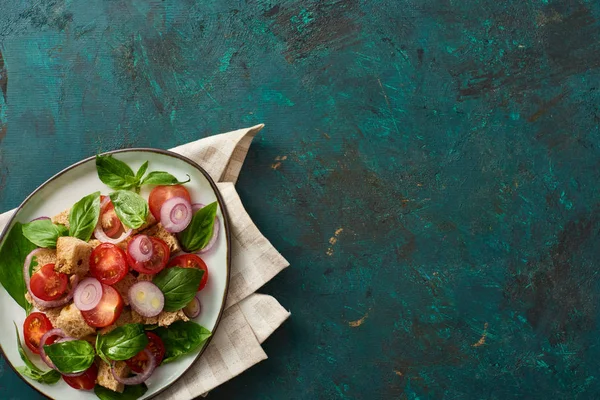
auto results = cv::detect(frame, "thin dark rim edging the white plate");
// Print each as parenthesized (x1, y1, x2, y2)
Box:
(0, 147, 231, 400)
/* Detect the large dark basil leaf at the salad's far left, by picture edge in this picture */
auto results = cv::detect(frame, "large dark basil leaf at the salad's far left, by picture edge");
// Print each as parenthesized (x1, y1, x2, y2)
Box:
(0, 222, 37, 312)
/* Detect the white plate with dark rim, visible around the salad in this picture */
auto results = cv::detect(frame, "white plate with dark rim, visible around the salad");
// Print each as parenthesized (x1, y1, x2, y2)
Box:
(0, 149, 230, 400)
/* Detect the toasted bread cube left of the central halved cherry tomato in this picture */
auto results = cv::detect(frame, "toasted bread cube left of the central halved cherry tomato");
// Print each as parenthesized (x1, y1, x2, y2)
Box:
(54, 236, 94, 276)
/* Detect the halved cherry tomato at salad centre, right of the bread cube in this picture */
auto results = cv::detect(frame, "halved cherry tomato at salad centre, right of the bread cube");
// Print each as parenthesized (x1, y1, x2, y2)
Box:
(90, 243, 129, 285)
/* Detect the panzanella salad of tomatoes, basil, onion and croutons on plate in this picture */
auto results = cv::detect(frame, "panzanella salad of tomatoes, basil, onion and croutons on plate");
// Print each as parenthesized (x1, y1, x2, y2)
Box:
(0, 156, 219, 399)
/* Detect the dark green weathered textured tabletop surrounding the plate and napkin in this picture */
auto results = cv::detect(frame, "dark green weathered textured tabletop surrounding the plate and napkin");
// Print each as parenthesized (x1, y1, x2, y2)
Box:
(0, 0, 600, 400)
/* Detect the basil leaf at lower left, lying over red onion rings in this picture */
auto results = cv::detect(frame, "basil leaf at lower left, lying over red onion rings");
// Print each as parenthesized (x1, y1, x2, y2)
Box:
(44, 340, 96, 374)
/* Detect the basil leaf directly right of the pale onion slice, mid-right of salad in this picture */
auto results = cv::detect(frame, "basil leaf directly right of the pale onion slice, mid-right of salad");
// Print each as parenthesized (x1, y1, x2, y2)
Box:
(152, 267, 204, 311)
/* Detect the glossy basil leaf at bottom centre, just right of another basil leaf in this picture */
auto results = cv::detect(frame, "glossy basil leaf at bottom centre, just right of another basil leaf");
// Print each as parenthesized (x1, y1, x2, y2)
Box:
(96, 324, 148, 361)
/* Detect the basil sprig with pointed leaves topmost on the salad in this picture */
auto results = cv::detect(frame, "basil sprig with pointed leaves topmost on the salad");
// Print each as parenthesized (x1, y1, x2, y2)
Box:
(96, 155, 190, 192)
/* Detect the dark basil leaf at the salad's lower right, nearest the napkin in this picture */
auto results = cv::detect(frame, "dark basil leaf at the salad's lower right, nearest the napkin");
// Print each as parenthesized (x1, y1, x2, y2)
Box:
(154, 321, 211, 364)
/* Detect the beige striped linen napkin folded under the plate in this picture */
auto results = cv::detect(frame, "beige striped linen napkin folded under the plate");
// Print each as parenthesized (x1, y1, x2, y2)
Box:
(0, 125, 290, 400)
